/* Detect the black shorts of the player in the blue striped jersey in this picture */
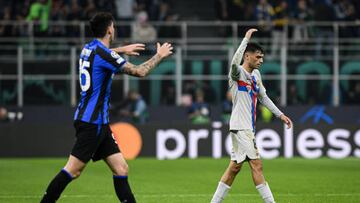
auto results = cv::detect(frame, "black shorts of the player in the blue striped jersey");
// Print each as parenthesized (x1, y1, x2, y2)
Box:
(71, 120, 120, 163)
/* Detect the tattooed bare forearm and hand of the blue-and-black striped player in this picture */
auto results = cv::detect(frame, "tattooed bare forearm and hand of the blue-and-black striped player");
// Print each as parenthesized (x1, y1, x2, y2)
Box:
(122, 43, 173, 77)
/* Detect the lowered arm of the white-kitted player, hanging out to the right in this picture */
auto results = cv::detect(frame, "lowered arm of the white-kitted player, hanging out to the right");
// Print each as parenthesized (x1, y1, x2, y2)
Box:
(258, 74, 292, 128)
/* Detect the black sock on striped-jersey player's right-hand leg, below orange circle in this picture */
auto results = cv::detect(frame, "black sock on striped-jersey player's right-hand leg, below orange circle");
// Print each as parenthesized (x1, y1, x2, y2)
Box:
(113, 175, 136, 203)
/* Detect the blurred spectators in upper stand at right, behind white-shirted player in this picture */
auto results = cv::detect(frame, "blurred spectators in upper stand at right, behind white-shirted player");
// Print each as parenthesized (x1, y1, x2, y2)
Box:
(215, 0, 360, 59)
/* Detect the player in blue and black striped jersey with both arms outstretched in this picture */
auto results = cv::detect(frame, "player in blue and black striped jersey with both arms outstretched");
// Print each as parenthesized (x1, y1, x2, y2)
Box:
(41, 12, 173, 203)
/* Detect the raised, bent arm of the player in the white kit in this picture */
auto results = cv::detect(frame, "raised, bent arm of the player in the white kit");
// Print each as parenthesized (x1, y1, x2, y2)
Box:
(230, 28, 257, 81)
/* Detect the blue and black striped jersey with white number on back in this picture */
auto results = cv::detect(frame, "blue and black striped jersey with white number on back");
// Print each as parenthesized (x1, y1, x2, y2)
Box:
(74, 39, 126, 124)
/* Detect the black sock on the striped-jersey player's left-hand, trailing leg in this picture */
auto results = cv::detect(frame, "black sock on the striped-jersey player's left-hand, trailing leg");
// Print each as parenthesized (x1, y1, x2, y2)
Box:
(41, 169, 73, 203)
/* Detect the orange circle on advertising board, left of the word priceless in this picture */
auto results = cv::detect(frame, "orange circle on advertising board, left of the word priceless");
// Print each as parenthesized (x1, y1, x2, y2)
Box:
(110, 122, 142, 160)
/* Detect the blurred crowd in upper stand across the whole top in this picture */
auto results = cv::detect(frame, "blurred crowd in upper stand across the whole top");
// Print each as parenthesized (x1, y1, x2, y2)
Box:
(0, 0, 360, 53)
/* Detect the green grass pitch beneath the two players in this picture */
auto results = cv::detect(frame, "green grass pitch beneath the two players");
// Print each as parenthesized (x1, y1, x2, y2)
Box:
(0, 158, 360, 203)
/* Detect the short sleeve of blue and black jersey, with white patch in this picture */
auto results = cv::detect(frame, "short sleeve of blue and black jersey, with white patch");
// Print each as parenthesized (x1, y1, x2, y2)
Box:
(95, 47, 126, 73)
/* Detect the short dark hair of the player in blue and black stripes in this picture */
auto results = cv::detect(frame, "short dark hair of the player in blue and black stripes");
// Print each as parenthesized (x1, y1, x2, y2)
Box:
(90, 12, 115, 38)
